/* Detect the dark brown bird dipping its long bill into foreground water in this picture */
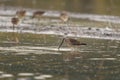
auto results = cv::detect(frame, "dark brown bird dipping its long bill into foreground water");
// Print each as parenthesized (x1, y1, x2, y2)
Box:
(58, 38, 87, 50)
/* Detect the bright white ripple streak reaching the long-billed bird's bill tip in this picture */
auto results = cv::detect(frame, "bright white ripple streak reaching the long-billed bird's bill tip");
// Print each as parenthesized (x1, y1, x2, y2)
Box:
(0, 46, 72, 55)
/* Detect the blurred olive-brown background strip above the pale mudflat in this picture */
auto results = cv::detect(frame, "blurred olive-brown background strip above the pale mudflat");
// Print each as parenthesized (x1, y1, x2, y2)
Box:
(0, 0, 120, 15)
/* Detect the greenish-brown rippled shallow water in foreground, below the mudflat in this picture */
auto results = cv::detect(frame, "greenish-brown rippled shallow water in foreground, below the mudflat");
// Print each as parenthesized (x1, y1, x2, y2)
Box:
(0, 34, 120, 80)
